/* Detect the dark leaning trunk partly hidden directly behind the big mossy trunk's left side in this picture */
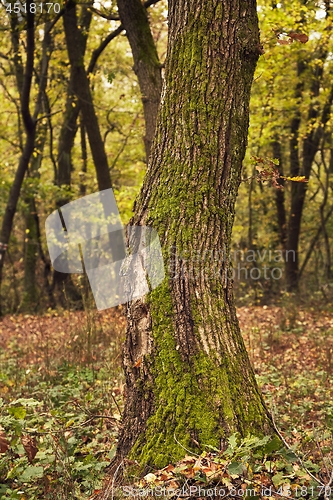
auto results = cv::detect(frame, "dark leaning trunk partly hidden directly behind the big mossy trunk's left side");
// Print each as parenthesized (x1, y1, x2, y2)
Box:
(117, 0, 162, 162)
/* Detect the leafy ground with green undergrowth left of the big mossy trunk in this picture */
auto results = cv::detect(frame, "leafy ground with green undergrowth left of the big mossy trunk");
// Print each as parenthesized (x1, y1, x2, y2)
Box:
(0, 310, 122, 500)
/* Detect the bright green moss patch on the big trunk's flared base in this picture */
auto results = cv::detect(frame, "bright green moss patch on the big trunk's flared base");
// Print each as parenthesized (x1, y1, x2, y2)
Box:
(130, 281, 265, 467)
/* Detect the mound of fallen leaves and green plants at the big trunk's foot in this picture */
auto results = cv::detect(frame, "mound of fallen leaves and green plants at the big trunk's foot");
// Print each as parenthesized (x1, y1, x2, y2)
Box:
(113, 434, 331, 500)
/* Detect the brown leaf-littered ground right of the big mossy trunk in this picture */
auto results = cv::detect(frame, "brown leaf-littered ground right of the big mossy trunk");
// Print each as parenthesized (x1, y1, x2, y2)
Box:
(239, 305, 333, 469)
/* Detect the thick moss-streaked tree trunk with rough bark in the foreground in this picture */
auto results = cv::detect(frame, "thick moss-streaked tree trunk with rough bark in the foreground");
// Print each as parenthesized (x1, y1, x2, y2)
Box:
(118, 0, 271, 466)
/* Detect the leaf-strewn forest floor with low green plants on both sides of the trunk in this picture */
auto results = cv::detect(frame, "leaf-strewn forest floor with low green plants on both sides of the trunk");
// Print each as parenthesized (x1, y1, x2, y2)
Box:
(0, 304, 333, 500)
